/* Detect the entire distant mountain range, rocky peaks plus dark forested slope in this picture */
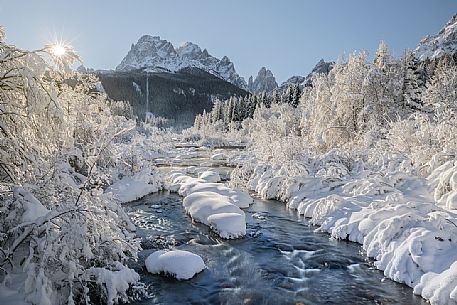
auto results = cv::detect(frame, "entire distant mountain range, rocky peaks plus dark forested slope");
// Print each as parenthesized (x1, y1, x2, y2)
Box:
(90, 14, 457, 126)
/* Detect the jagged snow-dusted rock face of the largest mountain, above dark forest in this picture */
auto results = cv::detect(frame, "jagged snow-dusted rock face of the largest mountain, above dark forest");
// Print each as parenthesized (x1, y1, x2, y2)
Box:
(116, 35, 247, 89)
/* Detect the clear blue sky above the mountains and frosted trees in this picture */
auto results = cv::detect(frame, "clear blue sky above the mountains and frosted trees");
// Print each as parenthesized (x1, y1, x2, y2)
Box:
(0, 0, 457, 83)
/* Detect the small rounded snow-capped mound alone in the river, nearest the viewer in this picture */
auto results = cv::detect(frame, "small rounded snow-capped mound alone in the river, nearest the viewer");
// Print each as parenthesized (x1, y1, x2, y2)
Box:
(145, 250, 206, 280)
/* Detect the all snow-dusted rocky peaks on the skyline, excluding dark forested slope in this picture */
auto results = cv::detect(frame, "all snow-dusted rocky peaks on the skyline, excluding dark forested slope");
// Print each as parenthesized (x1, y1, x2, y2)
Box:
(106, 14, 457, 93)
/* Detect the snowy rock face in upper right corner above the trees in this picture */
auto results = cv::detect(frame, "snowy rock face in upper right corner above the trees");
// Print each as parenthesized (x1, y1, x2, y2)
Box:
(414, 14, 457, 60)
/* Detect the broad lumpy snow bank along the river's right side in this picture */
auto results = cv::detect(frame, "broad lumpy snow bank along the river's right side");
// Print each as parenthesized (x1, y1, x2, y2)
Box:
(239, 160, 457, 305)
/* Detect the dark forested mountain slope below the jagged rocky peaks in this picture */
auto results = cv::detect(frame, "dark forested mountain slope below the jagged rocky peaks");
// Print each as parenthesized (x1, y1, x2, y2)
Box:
(98, 68, 248, 127)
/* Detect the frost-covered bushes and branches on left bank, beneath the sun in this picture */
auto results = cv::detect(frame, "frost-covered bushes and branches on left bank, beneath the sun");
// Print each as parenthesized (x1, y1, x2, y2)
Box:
(0, 30, 161, 305)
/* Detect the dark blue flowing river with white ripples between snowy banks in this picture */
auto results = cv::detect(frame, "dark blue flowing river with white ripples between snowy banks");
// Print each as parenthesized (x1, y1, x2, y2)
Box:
(127, 148, 427, 305)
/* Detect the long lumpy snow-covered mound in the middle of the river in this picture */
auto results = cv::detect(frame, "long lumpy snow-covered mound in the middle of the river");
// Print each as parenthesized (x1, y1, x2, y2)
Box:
(166, 171, 254, 238)
